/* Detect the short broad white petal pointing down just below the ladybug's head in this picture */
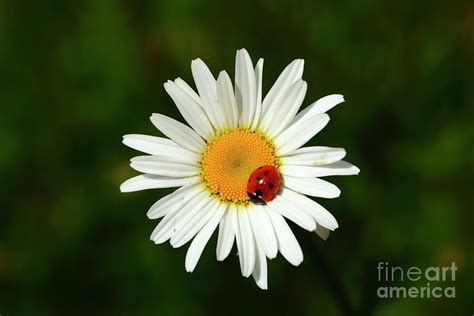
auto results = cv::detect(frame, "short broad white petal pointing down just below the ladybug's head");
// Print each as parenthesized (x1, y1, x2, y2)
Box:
(247, 205, 278, 259)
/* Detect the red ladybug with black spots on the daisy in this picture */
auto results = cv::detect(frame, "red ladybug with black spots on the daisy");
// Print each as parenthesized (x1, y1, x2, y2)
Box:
(247, 166, 280, 204)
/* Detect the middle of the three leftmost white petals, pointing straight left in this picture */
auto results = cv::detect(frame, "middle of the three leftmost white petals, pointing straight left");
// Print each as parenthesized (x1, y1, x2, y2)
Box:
(130, 156, 200, 178)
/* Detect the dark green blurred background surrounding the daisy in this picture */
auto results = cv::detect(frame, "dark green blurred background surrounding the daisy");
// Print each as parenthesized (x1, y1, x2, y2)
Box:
(0, 0, 474, 316)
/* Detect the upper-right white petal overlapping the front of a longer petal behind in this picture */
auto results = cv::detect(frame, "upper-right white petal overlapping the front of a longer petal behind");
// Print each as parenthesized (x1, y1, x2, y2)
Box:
(263, 79, 307, 138)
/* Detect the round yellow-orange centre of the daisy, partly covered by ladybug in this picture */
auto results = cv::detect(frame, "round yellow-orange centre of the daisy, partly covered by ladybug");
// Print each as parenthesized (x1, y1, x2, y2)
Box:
(201, 129, 278, 203)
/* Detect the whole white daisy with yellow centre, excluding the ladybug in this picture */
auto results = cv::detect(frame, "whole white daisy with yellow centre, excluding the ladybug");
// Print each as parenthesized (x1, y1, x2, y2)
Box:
(120, 49, 359, 289)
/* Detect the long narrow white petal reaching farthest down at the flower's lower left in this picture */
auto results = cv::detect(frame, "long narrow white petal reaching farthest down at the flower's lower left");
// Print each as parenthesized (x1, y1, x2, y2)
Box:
(185, 204, 226, 272)
